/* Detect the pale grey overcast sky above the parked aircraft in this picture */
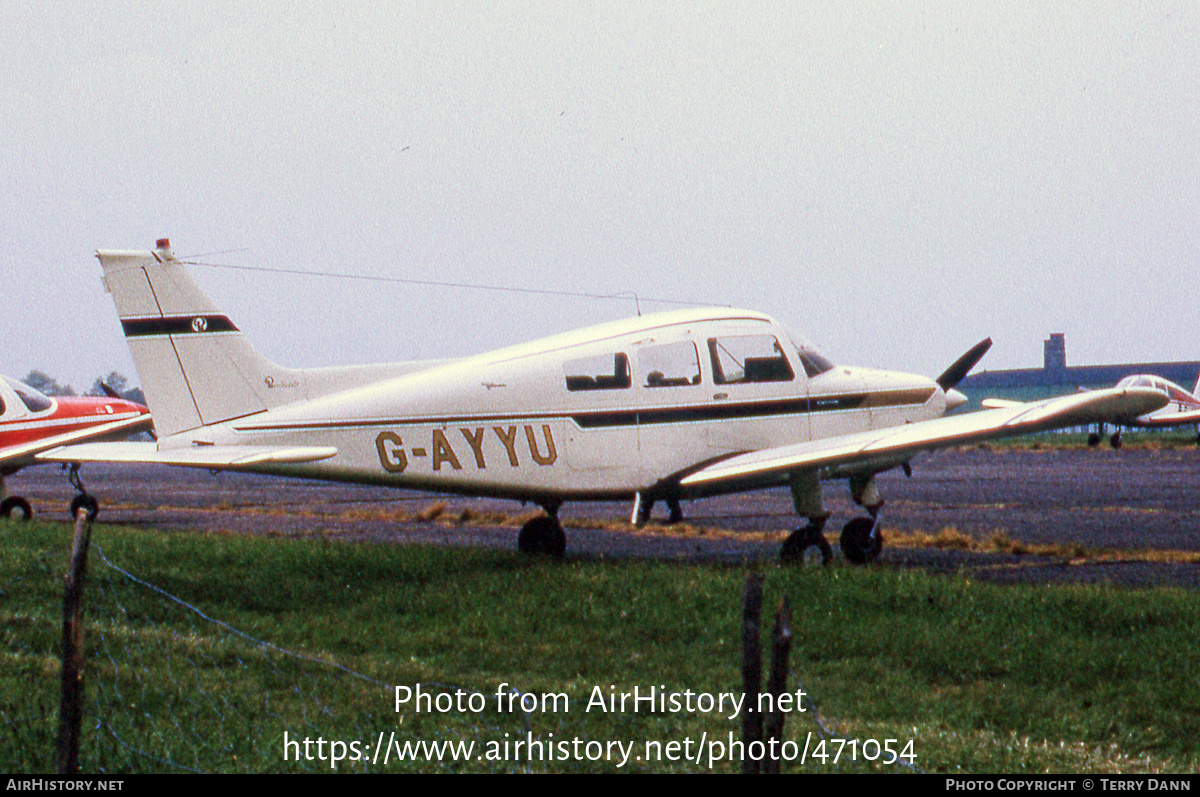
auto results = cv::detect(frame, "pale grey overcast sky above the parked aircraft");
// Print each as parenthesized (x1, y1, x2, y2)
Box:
(0, 0, 1200, 390)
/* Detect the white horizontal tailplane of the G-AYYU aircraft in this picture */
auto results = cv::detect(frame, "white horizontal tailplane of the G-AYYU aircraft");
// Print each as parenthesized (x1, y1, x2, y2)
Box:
(37, 442, 337, 471)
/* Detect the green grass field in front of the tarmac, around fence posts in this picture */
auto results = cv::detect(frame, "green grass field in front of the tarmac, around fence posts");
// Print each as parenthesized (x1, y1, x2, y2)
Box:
(0, 522, 1200, 773)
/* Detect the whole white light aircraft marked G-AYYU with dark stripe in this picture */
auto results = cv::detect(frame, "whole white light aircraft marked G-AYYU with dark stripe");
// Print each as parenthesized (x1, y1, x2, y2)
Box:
(42, 239, 1166, 563)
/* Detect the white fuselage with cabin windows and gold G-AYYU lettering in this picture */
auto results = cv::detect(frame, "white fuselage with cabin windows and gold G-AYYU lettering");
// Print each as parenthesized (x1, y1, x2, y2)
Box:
(174, 311, 946, 501)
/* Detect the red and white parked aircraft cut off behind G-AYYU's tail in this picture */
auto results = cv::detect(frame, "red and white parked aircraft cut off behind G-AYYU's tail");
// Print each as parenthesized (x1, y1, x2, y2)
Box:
(0, 376, 152, 520)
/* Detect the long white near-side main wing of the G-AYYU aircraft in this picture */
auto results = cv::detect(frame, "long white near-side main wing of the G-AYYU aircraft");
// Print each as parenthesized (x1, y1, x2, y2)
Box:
(679, 388, 1168, 491)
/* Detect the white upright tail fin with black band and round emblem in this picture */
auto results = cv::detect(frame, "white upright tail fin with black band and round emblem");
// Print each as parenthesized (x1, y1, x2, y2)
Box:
(96, 239, 304, 437)
